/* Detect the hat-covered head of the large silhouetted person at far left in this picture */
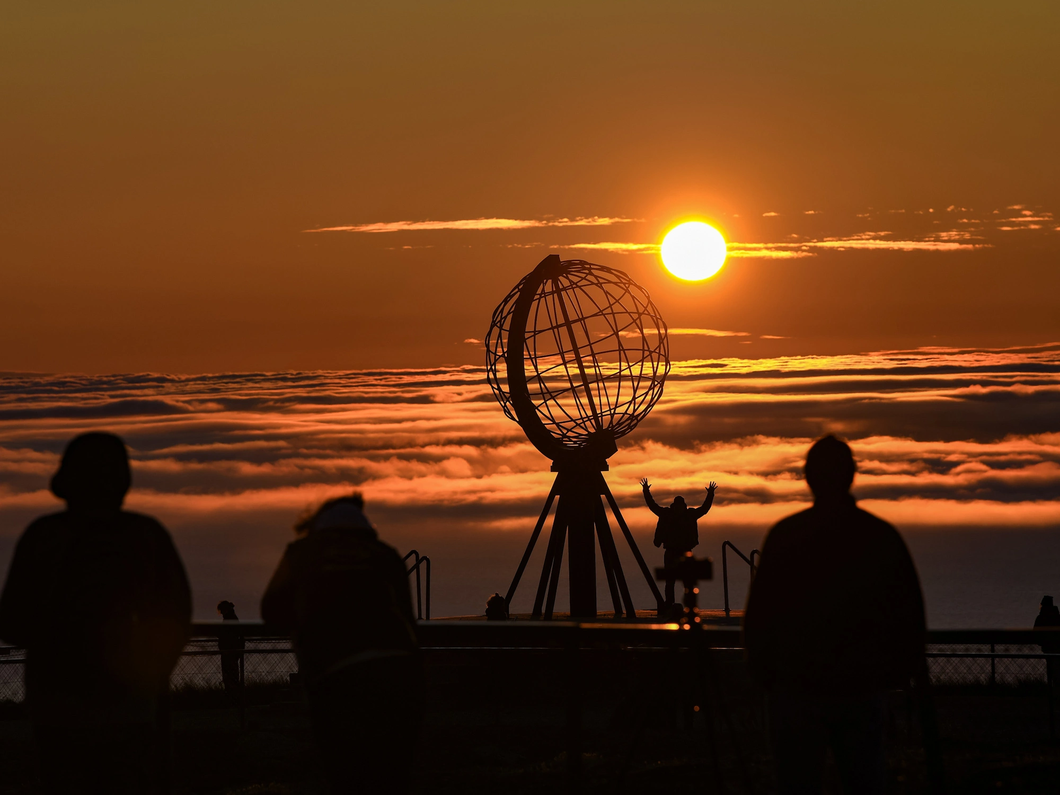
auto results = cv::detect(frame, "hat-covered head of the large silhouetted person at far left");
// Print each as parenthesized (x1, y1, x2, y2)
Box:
(52, 432, 133, 511)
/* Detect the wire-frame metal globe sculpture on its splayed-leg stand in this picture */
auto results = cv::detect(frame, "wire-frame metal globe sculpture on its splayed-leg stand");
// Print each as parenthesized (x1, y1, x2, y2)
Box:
(485, 254, 670, 618)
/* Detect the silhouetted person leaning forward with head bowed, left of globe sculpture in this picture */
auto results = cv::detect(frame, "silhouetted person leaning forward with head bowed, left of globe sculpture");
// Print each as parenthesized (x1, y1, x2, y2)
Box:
(262, 495, 422, 793)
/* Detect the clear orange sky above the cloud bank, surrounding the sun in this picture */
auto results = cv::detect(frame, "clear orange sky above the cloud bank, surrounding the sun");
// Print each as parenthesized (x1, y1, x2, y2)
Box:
(0, 2, 1060, 373)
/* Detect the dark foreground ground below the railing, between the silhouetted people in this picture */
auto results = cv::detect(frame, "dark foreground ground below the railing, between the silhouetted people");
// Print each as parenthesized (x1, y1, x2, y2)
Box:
(0, 650, 1060, 795)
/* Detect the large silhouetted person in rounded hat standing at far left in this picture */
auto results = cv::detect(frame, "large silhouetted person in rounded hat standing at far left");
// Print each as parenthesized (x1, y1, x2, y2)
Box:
(0, 434, 191, 794)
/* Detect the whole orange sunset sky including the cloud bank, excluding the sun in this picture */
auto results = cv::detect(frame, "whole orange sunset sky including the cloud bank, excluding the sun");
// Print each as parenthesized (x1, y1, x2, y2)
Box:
(0, 2, 1060, 618)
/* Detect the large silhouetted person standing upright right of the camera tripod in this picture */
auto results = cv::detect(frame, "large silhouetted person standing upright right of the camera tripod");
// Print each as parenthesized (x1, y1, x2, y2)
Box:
(743, 436, 925, 795)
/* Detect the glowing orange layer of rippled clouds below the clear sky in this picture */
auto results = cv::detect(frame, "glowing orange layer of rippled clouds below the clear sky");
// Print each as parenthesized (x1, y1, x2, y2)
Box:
(0, 343, 1060, 623)
